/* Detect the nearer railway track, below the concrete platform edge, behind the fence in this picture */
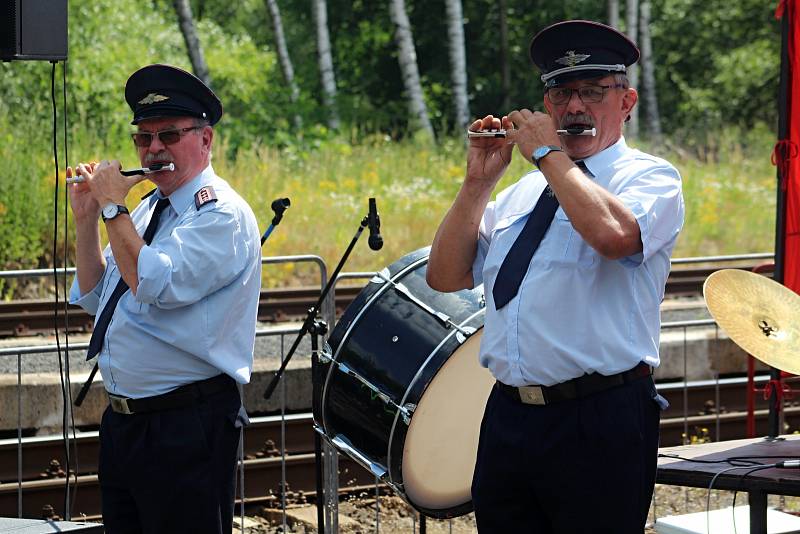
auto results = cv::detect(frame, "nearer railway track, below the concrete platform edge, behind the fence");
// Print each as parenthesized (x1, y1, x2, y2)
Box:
(0, 377, 800, 517)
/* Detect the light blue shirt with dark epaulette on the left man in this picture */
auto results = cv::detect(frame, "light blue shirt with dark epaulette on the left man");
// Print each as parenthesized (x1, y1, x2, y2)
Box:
(70, 165, 261, 398)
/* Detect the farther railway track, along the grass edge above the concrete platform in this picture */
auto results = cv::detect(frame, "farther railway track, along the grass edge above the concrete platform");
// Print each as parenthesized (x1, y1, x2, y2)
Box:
(0, 262, 772, 337)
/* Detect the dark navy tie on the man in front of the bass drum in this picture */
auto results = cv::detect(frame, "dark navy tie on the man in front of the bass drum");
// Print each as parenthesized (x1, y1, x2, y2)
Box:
(492, 185, 558, 310)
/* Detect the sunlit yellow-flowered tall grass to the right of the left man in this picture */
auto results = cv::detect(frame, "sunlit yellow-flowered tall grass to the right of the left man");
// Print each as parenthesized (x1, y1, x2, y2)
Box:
(214, 129, 775, 286)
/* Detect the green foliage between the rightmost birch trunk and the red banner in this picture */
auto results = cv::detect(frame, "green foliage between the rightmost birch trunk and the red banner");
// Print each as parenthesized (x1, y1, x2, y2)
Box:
(652, 0, 780, 131)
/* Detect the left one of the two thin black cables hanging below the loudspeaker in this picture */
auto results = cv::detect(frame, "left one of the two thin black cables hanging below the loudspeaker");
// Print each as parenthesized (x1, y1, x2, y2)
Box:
(50, 61, 70, 520)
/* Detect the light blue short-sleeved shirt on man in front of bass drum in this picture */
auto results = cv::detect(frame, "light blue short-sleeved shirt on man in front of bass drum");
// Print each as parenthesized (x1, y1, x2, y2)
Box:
(472, 138, 684, 386)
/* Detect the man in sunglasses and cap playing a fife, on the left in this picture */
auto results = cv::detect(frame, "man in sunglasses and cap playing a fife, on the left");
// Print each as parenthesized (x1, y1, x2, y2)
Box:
(67, 65, 261, 534)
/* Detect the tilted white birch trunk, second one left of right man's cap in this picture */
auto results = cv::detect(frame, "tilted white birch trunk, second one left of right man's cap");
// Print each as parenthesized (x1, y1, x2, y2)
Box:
(389, 0, 434, 138)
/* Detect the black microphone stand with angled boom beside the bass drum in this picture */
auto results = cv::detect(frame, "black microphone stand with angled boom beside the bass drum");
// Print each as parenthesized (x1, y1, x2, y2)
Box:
(264, 205, 376, 534)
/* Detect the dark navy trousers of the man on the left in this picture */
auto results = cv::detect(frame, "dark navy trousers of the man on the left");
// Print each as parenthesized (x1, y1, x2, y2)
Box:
(99, 379, 241, 534)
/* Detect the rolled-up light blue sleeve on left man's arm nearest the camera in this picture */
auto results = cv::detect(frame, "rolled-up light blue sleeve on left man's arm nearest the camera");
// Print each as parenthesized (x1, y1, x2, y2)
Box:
(136, 209, 250, 309)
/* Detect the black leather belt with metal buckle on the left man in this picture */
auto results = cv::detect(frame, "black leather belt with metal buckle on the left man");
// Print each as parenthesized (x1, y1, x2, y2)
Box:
(108, 374, 236, 415)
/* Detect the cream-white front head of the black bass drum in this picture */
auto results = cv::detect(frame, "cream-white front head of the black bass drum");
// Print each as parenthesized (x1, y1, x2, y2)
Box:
(403, 329, 495, 510)
